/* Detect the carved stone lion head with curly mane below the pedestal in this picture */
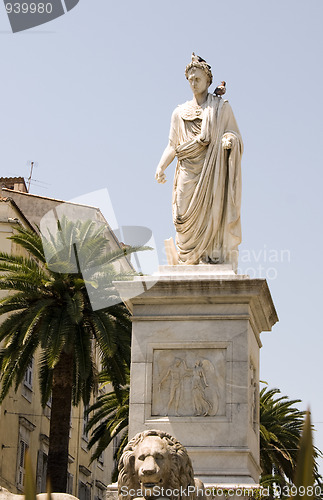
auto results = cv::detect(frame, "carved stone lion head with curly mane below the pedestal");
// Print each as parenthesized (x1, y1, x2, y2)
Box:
(118, 430, 203, 500)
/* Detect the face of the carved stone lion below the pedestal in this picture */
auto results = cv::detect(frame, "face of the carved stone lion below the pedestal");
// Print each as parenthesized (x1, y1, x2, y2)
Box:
(135, 436, 172, 496)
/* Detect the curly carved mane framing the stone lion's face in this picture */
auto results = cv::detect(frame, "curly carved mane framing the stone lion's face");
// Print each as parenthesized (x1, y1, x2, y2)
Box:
(118, 430, 202, 500)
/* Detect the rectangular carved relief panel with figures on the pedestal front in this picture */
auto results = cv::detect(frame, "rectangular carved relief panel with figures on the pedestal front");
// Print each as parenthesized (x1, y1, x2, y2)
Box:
(152, 348, 226, 417)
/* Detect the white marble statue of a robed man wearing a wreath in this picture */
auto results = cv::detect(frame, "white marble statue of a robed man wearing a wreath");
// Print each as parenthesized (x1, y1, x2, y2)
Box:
(156, 53, 243, 270)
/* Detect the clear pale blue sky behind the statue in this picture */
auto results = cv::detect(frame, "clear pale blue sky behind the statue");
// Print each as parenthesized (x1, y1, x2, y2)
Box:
(0, 0, 323, 474)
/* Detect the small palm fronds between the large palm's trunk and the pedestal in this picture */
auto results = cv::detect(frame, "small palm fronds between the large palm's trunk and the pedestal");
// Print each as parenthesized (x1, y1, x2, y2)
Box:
(86, 371, 130, 481)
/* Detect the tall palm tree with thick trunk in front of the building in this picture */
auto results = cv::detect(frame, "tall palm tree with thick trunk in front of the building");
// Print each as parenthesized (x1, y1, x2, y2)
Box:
(0, 219, 138, 492)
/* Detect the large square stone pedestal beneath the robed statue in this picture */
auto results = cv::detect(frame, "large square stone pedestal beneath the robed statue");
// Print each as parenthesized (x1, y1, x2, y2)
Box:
(118, 265, 277, 484)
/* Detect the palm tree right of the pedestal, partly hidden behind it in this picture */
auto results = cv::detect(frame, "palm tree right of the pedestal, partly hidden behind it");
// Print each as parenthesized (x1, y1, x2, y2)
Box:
(260, 387, 322, 486)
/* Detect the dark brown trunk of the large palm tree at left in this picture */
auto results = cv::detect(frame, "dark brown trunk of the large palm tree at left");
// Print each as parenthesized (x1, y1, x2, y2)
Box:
(47, 352, 73, 493)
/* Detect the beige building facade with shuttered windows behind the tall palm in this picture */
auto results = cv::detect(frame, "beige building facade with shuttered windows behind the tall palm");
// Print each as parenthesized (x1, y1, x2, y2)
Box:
(0, 178, 131, 500)
